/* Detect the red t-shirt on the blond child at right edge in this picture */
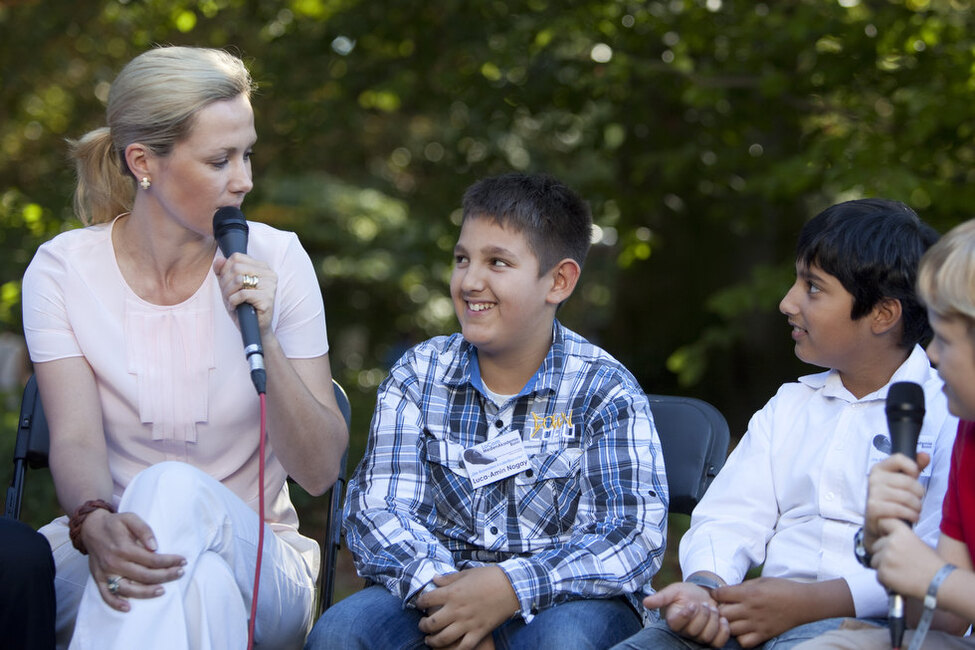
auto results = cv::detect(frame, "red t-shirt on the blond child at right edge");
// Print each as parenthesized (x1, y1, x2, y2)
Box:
(941, 420, 975, 566)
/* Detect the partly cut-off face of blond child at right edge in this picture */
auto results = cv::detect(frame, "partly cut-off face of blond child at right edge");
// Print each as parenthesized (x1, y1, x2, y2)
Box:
(928, 310, 975, 420)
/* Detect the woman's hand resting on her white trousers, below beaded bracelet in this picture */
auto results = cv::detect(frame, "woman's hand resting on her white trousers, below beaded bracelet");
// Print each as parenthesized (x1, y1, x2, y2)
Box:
(81, 509, 186, 612)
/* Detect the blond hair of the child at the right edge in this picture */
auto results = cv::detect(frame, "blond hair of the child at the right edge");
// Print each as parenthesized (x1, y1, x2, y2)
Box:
(917, 219, 975, 330)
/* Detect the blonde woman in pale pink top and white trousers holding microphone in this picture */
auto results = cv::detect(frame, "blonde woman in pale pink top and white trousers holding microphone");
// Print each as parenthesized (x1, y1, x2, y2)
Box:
(23, 47, 348, 649)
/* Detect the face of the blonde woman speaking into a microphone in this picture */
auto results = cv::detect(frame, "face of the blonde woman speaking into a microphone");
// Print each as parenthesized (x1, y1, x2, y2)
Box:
(140, 95, 257, 235)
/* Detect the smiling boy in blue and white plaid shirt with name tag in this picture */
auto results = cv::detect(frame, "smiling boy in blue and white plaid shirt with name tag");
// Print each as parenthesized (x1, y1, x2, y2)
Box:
(306, 174, 668, 650)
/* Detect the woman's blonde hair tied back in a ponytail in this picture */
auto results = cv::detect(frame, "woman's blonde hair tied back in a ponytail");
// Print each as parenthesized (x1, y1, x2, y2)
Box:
(69, 46, 255, 225)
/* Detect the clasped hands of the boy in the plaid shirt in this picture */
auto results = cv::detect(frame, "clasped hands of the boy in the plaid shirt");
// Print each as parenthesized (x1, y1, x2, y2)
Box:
(416, 566, 519, 650)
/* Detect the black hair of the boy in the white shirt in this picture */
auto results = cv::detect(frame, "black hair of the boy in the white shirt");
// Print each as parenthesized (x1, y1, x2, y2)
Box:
(796, 199, 939, 348)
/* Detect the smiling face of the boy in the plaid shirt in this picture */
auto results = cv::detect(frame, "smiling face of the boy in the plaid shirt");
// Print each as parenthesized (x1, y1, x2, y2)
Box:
(450, 217, 564, 363)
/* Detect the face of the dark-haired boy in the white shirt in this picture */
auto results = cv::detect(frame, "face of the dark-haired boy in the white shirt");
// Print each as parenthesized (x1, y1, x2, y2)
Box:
(779, 256, 871, 374)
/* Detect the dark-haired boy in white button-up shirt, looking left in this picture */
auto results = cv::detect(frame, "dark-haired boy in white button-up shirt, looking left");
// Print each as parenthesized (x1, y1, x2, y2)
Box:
(617, 199, 957, 650)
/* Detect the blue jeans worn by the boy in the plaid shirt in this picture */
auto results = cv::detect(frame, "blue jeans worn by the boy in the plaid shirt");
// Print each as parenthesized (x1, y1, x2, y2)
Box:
(305, 585, 640, 650)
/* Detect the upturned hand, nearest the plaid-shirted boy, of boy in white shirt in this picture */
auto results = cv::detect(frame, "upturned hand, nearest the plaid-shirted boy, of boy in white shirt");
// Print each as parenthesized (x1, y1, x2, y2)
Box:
(643, 582, 731, 648)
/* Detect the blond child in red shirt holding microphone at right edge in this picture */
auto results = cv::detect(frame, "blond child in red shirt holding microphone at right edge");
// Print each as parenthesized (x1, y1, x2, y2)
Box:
(802, 220, 975, 650)
